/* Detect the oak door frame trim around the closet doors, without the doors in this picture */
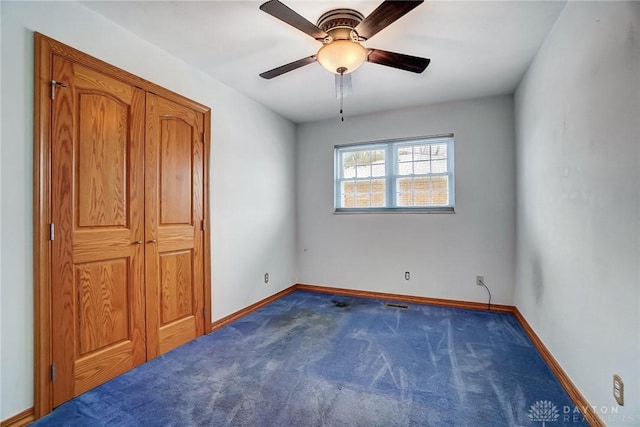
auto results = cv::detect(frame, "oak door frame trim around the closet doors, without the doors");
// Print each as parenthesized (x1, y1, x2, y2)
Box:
(33, 32, 211, 419)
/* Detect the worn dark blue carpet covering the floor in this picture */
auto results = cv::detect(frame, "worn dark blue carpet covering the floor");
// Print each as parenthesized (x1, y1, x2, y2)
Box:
(33, 291, 588, 427)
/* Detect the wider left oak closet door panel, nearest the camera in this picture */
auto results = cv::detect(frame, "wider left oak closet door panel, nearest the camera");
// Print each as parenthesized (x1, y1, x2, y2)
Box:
(51, 56, 146, 407)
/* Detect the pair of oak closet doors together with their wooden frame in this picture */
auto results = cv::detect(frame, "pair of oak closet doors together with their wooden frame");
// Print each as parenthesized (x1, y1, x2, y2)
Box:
(33, 33, 211, 417)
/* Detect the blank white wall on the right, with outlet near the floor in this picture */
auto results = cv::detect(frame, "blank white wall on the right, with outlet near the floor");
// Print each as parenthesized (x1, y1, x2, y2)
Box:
(515, 2, 640, 426)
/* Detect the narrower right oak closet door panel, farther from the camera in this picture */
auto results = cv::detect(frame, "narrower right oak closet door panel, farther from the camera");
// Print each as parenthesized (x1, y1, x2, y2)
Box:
(145, 93, 204, 359)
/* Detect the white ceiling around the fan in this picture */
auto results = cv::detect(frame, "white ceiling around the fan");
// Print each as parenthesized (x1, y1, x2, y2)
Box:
(84, 0, 565, 123)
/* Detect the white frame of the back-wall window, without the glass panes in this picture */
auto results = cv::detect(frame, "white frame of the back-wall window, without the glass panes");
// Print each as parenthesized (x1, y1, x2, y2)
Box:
(333, 134, 455, 214)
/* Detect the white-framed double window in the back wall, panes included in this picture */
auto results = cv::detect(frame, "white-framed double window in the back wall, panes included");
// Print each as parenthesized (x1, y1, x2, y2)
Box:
(335, 135, 454, 212)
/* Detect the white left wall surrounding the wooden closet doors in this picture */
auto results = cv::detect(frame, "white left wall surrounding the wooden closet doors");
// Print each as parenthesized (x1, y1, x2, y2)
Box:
(0, 2, 296, 420)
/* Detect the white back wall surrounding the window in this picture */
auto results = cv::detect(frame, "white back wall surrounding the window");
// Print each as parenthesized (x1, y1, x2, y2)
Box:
(297, 96, 516, 304)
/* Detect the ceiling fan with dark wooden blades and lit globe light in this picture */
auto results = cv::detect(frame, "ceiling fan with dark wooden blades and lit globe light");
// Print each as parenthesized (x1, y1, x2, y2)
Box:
(260, 0, 431, 79)
